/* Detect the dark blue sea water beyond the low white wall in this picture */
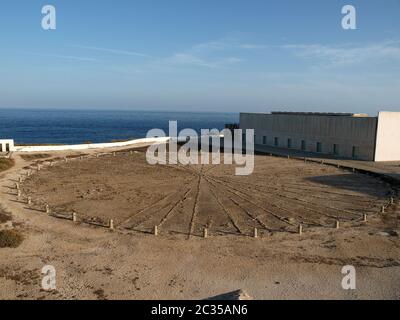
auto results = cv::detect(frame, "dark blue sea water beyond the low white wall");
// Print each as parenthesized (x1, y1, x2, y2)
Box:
(0, 109, 239, 144)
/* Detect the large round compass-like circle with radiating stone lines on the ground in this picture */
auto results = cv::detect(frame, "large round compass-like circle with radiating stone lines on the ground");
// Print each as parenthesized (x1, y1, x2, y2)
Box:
(22, 151, 391, 236)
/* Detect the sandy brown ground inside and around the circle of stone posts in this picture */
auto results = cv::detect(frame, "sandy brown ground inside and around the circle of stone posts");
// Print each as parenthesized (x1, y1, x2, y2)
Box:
(0, 150, 400, 299)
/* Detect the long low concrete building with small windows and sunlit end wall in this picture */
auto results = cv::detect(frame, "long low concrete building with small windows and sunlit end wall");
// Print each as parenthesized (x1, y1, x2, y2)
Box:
(240, 112, 400, 161)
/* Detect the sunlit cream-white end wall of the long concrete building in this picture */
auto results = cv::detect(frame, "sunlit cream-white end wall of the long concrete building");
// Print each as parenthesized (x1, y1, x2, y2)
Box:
(375, 112, 400, 161)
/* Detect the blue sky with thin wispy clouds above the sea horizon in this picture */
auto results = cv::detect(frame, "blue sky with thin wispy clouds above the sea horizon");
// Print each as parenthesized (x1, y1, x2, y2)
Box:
(0, 0, 400, 115)
